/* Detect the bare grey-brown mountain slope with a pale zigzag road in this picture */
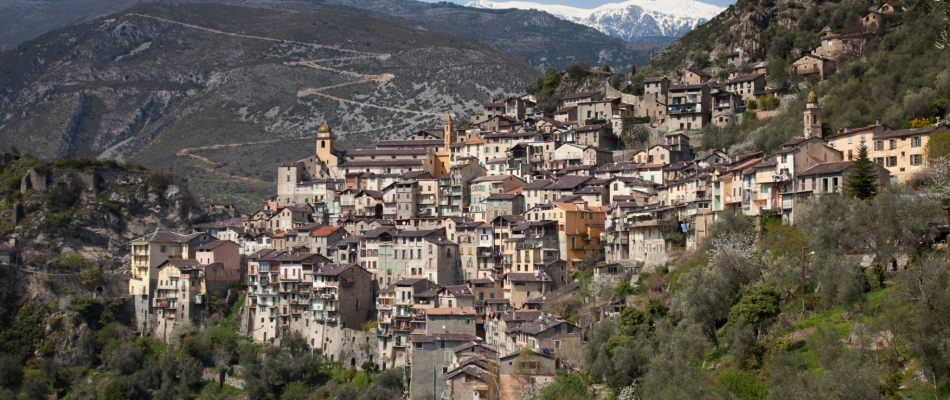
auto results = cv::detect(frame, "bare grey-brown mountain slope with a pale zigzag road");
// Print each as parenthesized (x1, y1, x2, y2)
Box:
(0, 3, 538, 209)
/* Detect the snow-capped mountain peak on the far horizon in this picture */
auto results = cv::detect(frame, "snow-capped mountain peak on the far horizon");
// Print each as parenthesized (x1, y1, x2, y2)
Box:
(466, 0, 725, 42)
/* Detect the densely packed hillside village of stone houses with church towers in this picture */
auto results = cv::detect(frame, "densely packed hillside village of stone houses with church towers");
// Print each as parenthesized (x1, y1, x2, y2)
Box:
(104, 3, 950, 399)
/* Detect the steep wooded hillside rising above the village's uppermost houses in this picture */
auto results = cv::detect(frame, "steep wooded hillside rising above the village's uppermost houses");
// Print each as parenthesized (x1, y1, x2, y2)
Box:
(633, 0, 950, 153)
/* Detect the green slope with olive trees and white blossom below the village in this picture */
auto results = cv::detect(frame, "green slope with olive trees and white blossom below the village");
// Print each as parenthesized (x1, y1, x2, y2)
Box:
(541, 186, 950, 399)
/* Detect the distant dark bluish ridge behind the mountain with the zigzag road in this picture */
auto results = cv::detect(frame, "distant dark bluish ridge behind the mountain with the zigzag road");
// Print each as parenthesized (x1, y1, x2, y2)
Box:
(0, 0, 669, 69)
